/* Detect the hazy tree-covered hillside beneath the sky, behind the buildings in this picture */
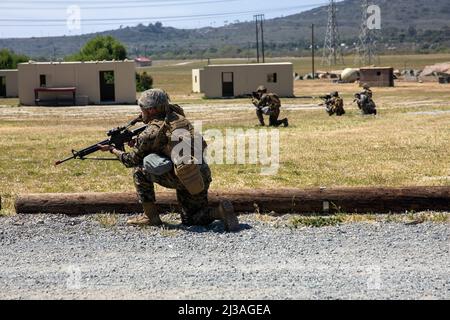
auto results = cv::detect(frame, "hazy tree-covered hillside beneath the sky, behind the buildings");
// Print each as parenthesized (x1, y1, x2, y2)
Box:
(0, 0, 450, 59)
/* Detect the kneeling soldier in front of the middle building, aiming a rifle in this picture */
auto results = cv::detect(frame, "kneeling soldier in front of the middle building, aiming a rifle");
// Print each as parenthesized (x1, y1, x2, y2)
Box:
(252, 86, 289, 127)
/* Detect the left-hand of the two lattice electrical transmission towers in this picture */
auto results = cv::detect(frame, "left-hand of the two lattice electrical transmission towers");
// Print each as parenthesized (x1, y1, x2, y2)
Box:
(322, 0, 344, 66)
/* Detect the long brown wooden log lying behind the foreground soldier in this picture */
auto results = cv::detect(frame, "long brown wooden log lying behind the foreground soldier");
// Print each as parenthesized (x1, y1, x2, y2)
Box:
(15, 187, 450, 215)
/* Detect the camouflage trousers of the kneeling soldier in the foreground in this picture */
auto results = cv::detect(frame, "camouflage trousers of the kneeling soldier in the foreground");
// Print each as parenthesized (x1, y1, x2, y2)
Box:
(133, 163, 214, 225)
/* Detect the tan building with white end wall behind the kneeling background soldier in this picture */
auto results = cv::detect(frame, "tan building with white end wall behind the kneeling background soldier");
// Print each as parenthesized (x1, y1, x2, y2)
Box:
(192, 62, 294, 98)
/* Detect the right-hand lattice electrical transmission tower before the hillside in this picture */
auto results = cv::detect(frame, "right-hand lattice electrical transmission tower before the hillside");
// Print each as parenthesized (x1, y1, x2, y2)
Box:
(355, 0, 377, 66)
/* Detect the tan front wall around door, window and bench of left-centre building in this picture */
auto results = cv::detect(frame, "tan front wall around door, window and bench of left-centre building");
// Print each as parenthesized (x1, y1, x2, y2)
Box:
(19, 61, 136, 105)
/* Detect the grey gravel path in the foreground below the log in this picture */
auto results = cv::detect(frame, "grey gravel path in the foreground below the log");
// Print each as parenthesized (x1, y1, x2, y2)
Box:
(0, 215, 450, 299)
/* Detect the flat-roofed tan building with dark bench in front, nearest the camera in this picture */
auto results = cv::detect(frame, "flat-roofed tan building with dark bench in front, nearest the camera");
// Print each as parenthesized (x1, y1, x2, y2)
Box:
(18, 61, 136, 105)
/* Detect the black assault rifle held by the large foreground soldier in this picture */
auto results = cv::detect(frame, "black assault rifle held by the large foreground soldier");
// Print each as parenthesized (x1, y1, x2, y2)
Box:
(55, 116, 147, 166)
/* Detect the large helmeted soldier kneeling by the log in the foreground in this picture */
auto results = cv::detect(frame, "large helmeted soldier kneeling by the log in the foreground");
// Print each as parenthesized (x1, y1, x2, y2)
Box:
(99, 89, 239, 231)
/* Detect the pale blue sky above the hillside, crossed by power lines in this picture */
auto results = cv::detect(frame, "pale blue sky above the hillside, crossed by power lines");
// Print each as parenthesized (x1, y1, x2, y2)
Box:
(0, 0, 327, 38)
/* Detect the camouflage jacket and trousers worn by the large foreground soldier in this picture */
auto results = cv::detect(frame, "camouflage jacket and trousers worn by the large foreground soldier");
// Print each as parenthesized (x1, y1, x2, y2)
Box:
(119, 113, 214, 225)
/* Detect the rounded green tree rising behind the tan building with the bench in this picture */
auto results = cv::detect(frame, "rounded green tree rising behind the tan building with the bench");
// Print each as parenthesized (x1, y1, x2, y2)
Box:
(65, 36, 127, 61)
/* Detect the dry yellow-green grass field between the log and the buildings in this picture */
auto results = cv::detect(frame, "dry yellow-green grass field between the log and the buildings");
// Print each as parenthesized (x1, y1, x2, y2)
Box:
(0, 55, 450, 215)
